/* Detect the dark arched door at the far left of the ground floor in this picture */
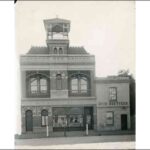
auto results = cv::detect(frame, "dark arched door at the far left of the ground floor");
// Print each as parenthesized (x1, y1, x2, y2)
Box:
(26, 110, 33, 131)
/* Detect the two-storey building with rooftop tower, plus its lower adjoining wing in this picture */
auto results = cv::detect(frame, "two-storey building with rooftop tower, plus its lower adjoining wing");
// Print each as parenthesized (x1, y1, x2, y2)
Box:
(20, 18, 130, 134)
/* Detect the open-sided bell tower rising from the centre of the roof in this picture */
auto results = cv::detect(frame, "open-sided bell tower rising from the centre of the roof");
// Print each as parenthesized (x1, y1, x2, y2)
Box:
(44, 18, 70, 54)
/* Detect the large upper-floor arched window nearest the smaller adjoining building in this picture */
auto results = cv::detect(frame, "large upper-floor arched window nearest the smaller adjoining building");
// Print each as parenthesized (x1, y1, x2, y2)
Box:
(70, 74, 89, 95)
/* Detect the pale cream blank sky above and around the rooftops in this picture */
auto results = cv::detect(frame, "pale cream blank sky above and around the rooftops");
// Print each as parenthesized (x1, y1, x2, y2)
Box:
(15, 1, 135, 77)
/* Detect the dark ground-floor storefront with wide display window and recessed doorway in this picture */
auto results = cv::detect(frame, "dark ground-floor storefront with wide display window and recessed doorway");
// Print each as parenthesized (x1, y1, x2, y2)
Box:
(53, 107, 93, 131)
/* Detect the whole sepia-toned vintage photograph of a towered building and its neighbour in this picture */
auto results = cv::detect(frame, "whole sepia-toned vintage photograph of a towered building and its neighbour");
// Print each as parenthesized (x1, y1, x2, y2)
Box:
(15, 1, 136, 149)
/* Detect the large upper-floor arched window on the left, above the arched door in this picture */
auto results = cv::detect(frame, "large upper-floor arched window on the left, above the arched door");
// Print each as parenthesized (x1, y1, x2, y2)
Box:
(28, 74, 49, 96)
